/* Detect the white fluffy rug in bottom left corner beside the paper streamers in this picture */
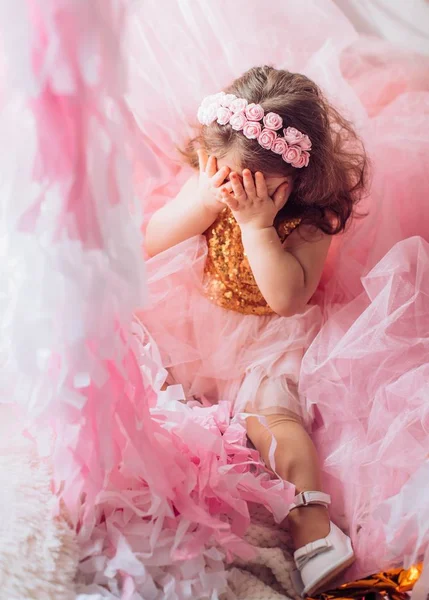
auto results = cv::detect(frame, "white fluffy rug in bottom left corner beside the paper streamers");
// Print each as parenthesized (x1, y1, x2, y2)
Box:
(0, 407, 77, 600)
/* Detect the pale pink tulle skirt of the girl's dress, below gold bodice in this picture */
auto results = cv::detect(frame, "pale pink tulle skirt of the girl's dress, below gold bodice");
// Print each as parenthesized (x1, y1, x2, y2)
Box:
(138, 236, 322, 425)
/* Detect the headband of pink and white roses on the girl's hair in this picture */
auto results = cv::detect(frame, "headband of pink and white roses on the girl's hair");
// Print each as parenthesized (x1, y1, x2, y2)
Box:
(198, 92, 311, 169)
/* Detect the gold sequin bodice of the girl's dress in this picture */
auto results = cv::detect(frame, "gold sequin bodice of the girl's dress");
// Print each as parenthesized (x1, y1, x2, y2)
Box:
(204, 209, 301, 315)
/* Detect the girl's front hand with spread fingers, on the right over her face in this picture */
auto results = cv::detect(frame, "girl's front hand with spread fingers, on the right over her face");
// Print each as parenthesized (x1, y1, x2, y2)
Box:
(221, 169, 289, 229)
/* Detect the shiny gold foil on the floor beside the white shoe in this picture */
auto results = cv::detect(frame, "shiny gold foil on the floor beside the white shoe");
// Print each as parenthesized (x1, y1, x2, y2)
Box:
(308, 564, 423, 600)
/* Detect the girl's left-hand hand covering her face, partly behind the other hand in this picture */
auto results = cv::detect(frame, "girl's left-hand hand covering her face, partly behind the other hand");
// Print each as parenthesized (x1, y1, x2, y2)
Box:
(197, 150, 230, 214)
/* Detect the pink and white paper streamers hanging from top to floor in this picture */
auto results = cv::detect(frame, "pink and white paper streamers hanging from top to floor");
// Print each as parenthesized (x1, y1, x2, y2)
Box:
(0, 0, 293, 600)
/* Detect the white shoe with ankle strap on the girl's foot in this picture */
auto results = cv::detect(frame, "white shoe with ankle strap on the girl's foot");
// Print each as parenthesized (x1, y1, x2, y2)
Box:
(289, 492, 355, 596)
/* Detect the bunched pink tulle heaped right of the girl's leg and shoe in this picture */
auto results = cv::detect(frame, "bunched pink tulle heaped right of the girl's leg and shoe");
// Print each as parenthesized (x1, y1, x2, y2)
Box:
(300, 237, 429, 575)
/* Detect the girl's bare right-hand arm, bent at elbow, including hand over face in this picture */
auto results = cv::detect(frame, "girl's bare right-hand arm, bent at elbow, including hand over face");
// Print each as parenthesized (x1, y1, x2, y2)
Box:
(221, 169, 331, 317)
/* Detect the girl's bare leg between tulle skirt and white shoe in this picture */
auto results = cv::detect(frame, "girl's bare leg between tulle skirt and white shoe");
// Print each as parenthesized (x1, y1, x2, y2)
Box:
(247, 412, 330, 548)
